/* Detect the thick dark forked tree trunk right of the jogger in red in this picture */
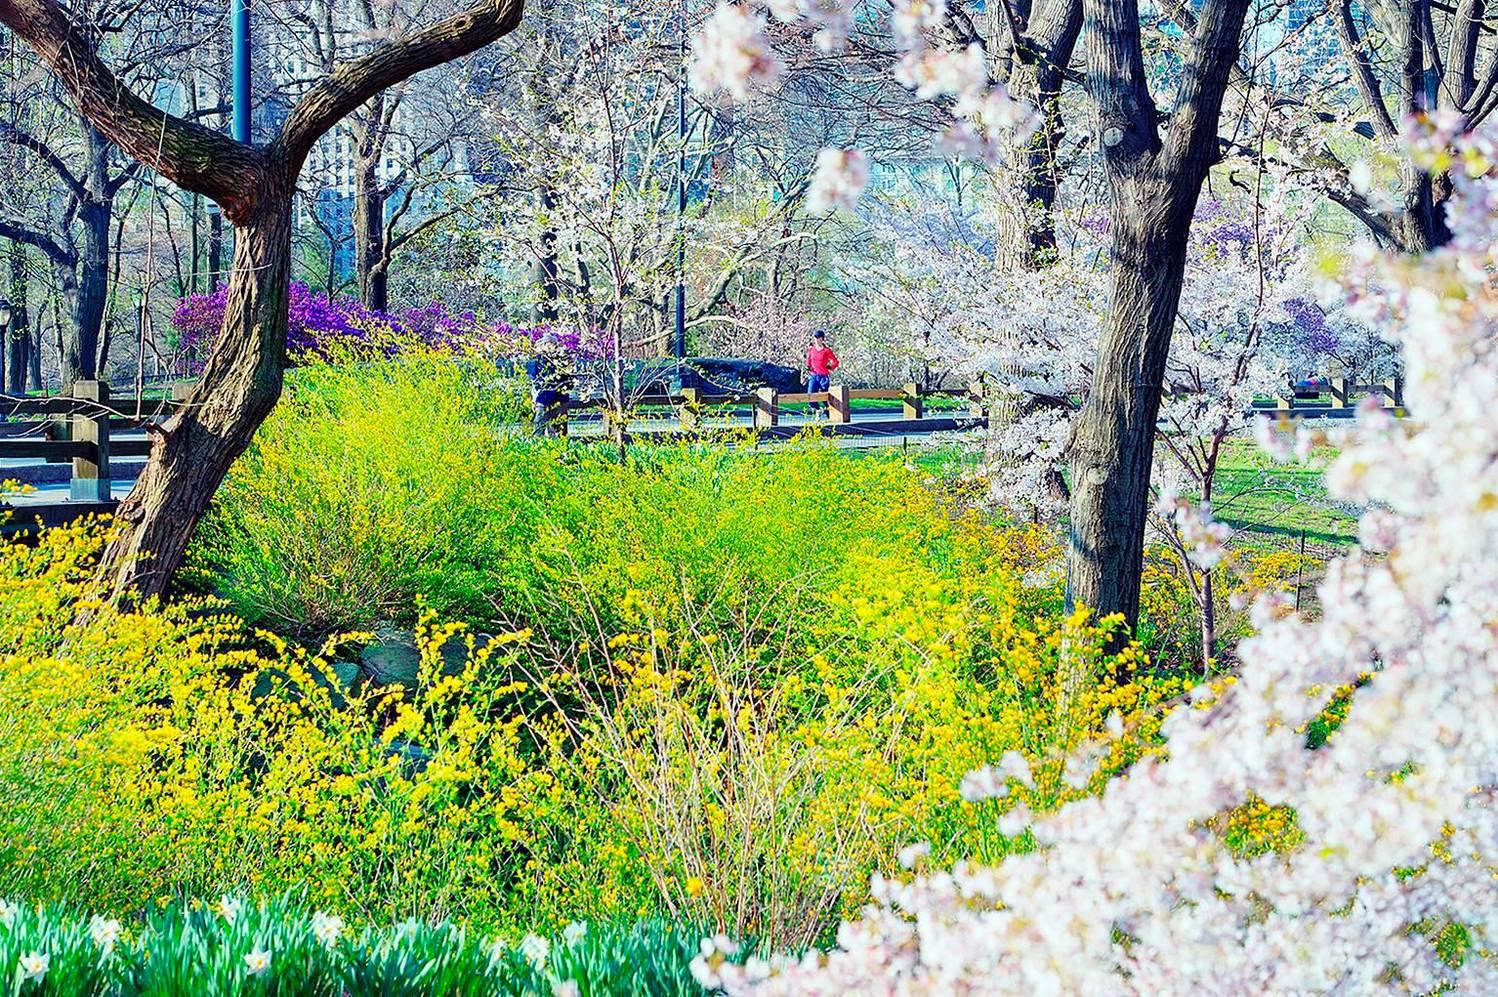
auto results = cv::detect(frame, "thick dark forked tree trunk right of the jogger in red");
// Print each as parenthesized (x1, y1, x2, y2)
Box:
(1067, 0, 1249, 632)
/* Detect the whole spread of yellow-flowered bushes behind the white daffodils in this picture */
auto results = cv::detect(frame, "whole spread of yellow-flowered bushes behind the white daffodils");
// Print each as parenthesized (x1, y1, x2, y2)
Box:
(0, 511, 1177, 945)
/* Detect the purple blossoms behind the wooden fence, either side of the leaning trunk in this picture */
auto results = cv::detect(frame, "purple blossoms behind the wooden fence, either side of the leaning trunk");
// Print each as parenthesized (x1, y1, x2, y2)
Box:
(172, 281, 607, 361)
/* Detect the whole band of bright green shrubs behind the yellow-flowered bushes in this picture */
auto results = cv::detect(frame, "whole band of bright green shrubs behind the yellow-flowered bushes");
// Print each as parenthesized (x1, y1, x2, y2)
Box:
(195, 358, 1024, 655)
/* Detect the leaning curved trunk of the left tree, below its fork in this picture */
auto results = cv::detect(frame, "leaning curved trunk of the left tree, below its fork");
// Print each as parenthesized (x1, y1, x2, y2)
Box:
(99, 180, 291, 600)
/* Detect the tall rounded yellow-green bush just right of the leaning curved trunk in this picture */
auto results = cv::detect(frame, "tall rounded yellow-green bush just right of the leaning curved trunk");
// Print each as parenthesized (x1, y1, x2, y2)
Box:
(195, 353, 529, 638)
